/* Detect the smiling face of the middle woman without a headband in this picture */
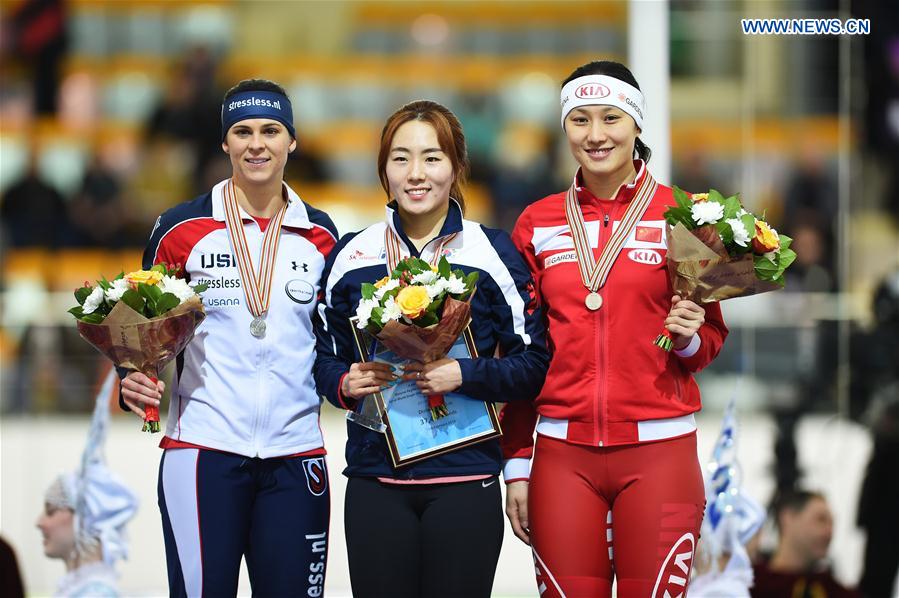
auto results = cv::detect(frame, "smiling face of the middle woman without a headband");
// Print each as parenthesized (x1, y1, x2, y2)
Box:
(385, 120, 455, 224)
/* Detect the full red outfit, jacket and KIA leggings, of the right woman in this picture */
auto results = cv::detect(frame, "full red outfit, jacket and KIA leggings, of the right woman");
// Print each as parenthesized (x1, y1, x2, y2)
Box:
(502, 161, 727, 598)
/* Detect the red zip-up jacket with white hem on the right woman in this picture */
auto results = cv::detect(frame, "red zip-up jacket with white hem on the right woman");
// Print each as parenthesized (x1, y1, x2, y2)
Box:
(502, 161, 727, 482)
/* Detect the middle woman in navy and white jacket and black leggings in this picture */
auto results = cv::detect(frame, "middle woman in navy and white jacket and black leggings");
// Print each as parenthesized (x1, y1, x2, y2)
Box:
(314, 101, 548, 596)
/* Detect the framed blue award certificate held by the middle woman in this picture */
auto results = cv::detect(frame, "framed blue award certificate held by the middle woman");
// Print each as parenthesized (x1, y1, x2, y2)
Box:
(352, 318, 501, 467)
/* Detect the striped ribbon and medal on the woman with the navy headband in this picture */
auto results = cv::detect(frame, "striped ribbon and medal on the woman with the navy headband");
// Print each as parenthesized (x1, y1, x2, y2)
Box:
(222, 180, 287, 338)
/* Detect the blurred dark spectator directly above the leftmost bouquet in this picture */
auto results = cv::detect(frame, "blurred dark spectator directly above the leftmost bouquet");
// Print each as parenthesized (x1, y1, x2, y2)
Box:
(69, 154, 133, 249)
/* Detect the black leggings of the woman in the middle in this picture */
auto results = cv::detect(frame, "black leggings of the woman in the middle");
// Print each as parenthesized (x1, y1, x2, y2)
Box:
(344, 477, 504, 598)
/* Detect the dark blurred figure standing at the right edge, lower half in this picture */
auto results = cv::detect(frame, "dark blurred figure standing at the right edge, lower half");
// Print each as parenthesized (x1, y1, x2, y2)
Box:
(851, 270, 899, 597)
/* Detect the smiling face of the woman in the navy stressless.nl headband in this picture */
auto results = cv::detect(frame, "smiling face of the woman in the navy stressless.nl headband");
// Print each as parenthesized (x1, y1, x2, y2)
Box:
(222, 118, 297, 185)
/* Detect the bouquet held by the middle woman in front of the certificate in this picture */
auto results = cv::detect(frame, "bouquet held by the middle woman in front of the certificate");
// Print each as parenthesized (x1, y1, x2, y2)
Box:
(356, 257, 478, 419)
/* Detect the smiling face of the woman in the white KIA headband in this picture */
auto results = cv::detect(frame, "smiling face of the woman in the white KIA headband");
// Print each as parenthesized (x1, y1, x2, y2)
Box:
(565, 106, 640, 196)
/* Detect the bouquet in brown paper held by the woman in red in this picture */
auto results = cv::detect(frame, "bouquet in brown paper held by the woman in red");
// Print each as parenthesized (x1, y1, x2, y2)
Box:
(654, 187, 796, 351)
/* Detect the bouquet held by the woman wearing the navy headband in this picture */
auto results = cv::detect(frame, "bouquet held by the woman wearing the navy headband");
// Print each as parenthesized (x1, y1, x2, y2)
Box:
(69, 264, 206, 432)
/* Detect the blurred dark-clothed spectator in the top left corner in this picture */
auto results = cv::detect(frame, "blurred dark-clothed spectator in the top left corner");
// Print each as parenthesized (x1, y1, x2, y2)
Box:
(0, 0, 68, 116)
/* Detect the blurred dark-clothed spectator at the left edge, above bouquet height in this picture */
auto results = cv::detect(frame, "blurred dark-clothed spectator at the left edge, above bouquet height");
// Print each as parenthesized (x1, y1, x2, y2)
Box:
(0, 153, 71, 248)
